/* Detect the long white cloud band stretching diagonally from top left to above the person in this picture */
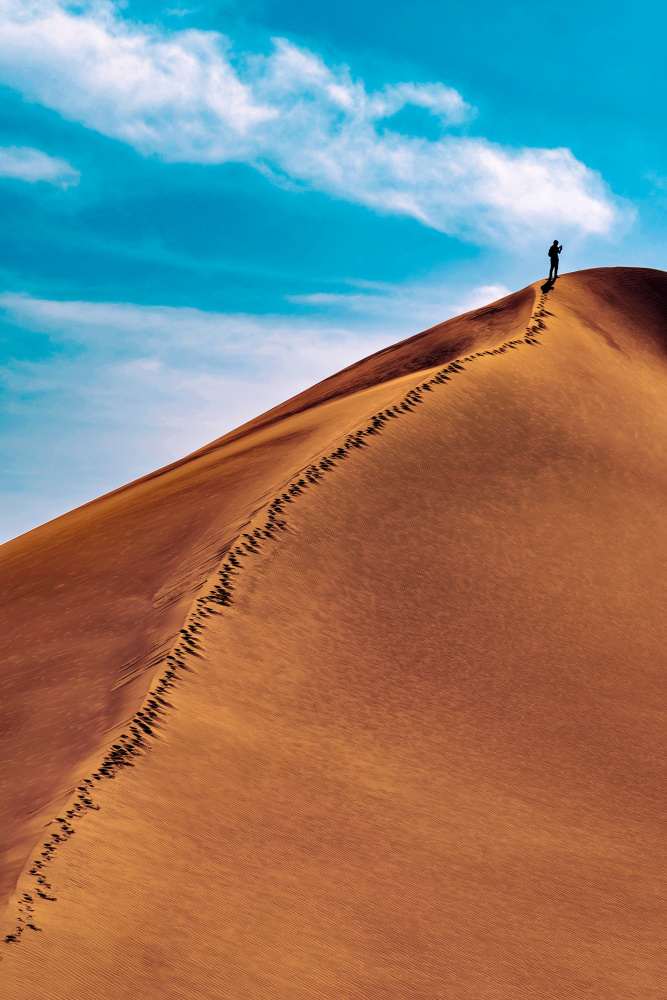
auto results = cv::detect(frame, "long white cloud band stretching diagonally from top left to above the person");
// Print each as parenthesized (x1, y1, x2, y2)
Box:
(0, 0, 629, 239)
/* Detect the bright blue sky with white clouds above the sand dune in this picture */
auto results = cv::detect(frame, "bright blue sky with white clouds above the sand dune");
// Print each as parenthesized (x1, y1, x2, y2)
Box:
(0, 0, 667, 540)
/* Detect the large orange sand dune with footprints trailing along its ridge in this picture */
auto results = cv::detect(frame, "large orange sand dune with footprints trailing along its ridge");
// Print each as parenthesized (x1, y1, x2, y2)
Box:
(0, 268, 667, 1000)
